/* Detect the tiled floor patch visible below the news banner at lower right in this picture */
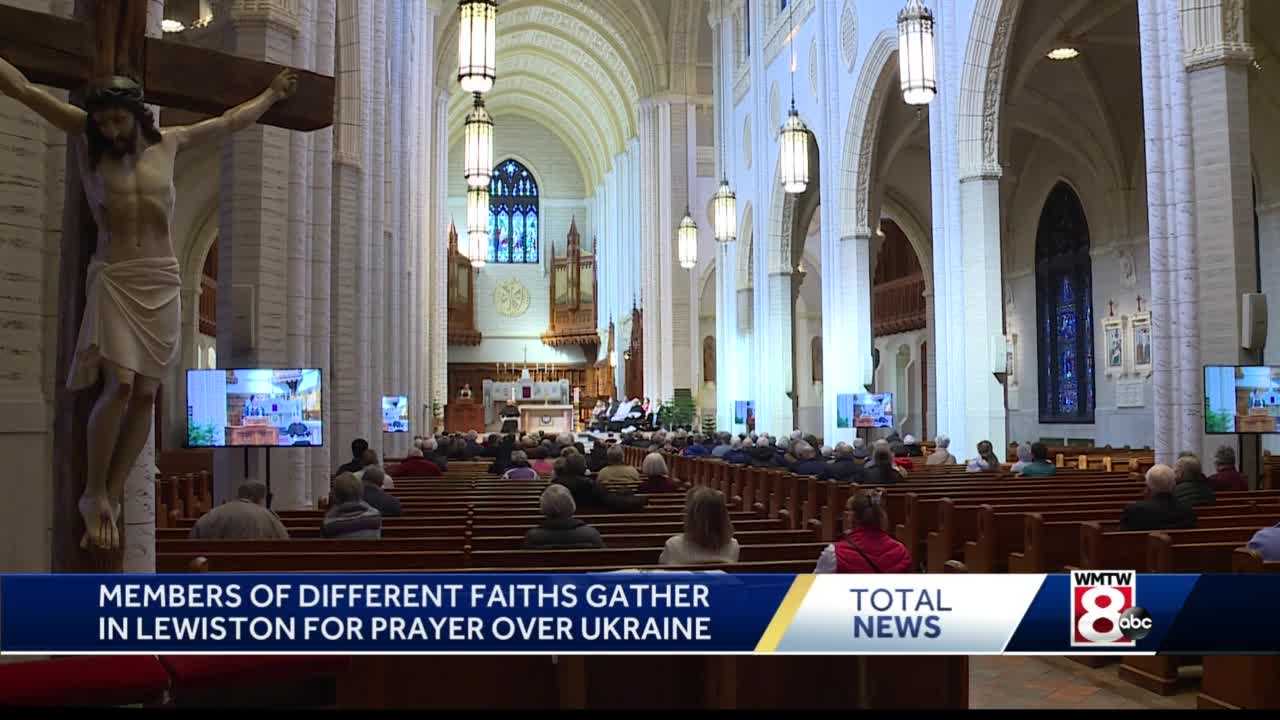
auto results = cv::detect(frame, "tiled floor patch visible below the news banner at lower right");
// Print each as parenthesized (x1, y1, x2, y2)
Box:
(969, 656, 1196, 710)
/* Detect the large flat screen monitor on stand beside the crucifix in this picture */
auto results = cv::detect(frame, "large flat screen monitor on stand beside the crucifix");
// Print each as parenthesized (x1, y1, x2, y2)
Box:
(187, 368, 324, 447)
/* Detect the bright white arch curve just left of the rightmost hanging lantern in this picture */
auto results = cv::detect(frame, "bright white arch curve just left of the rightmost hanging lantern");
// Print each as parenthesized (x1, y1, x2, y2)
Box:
(840, 29, 897, 237)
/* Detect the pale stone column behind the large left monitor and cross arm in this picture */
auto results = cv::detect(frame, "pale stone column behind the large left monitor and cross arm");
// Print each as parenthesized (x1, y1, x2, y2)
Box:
(215, 0, 307, 509)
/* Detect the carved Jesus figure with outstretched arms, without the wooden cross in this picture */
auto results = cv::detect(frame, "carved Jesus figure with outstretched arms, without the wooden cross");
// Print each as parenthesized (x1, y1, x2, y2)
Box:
(0, 58, 298, 550)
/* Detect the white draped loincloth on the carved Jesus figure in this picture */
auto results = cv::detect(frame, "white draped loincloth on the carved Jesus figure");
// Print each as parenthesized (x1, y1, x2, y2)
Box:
(67, 258, 182, 391)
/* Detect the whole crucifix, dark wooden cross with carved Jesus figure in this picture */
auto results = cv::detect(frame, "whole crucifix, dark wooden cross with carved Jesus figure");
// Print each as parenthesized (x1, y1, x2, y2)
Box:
(0, 0, 334, 570)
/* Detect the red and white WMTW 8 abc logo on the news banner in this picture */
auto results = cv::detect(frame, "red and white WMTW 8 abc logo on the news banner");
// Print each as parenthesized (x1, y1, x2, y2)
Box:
(1071, 570, 1151, 647)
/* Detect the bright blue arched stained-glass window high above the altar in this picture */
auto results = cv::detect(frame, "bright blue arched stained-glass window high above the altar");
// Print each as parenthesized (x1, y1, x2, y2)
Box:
(488, 160, 539, 263)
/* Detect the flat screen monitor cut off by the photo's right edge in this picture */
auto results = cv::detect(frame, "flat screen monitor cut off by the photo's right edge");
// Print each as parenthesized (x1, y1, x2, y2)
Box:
(1204, 365, 1280, 434)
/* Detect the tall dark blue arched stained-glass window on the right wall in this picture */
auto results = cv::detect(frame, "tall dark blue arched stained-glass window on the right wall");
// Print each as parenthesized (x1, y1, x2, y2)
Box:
(1036, 183, 1093, 423)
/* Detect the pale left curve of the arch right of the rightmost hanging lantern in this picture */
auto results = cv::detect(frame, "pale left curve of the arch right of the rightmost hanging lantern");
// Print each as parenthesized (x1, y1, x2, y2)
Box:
(956, 0, 1021, 178)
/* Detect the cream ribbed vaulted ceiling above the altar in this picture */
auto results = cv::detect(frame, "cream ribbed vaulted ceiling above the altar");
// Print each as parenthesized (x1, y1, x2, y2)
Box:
(436, 0, 712, 186)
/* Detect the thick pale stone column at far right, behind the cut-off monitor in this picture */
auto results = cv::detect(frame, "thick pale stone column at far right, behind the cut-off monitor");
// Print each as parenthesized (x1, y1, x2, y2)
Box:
(1166, 1, 1260, 457)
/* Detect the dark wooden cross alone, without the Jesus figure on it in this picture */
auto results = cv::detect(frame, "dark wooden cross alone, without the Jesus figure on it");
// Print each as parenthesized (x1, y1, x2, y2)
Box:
(0, 0, 334, 570)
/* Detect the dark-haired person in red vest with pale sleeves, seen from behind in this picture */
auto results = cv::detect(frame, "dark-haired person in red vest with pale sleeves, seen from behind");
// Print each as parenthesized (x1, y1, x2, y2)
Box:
(813, 488, 911, 573)
